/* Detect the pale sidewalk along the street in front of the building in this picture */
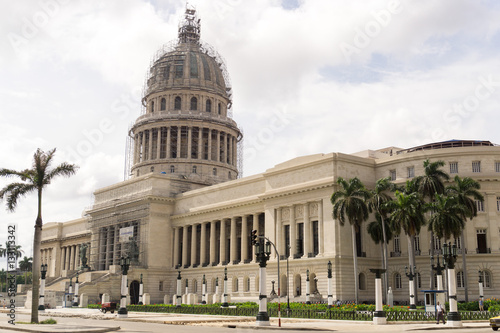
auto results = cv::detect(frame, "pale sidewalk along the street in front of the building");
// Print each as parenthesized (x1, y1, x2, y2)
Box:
(0, 308, 489, 333)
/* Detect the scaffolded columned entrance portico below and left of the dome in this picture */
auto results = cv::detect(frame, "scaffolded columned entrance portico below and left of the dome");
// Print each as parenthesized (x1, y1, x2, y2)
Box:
(87, 204, 149, 270)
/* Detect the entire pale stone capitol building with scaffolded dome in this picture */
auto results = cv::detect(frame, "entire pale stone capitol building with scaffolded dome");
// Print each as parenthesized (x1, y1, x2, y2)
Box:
(41, 9, 500, 304)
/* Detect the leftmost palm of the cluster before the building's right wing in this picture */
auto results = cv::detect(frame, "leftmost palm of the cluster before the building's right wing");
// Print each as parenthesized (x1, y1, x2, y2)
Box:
(330, 177, 370, 303)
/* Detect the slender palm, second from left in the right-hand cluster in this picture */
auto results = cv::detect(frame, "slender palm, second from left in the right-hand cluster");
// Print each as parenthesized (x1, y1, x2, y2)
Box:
(368, 177, 394, 295)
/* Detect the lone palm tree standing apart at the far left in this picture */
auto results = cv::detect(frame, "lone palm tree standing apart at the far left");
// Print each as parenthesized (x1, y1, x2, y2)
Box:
(0, 148, 78, 323)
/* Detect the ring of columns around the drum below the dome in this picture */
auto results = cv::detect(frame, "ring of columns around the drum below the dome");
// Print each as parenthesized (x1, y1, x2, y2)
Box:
(134, 125, 237, 166)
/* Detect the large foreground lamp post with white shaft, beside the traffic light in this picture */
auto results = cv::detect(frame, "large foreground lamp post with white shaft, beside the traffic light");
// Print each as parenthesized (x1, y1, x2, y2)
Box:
(255, 239, 271, 326)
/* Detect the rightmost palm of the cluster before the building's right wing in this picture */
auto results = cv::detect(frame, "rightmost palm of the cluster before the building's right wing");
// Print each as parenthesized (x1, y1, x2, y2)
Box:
(446, 176, 484, 302)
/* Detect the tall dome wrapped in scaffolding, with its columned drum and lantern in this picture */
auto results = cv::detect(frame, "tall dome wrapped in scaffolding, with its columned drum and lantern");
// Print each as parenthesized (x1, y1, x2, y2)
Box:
(129, 8, 242, 190)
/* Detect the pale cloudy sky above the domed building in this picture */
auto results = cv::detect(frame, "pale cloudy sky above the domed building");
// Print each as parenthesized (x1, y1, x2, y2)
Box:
(0, 0, 500, 260)
